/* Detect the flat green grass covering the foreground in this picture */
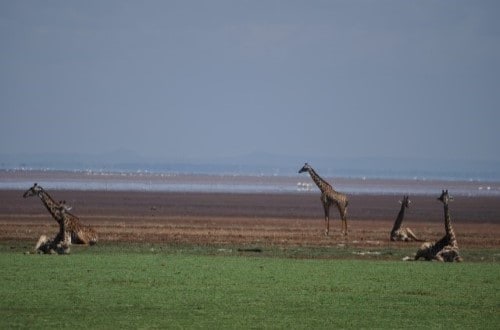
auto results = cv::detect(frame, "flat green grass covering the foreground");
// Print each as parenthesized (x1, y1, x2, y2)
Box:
(0, 247, 500, 329)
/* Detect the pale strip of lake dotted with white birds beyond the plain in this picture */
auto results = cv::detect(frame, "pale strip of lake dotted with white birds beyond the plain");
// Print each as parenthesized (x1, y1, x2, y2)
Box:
(0, 170, 500, 197)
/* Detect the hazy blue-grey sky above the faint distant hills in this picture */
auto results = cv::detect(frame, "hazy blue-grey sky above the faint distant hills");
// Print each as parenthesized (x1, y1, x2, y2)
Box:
(0, 0, 500, 161)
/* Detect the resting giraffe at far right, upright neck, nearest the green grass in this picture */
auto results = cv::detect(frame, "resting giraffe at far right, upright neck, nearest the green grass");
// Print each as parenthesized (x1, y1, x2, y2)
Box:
(415, 190, 463, 262)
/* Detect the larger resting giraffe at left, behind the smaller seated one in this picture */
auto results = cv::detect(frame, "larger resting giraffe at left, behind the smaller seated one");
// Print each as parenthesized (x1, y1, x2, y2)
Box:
(23, 183, 97, 253)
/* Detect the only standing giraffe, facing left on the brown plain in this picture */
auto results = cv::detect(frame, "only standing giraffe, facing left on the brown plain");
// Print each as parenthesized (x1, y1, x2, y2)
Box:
(299, 163, 349, 236)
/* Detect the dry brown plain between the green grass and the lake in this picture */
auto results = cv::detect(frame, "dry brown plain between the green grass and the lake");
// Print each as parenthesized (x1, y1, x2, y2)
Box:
(0, 190, 500, 255)
